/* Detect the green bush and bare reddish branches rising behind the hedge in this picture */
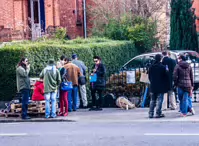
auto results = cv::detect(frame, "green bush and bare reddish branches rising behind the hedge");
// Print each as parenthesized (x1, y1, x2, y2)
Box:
(88, 0, 168, 52)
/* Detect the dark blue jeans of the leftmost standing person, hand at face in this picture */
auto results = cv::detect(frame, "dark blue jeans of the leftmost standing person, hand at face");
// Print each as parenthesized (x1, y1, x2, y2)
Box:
(20, 89, 30, 118)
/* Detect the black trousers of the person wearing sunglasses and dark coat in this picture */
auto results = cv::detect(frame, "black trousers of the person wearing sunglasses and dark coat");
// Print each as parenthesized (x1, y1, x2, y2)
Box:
(91, 89, 103, 108)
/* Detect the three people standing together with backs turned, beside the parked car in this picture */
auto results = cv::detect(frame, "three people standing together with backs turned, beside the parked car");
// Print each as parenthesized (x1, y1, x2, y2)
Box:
(149, 51, 195, 118)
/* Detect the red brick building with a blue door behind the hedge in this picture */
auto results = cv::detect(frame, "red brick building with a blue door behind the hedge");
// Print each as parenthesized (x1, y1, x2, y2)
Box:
(0, 0, 84, 41)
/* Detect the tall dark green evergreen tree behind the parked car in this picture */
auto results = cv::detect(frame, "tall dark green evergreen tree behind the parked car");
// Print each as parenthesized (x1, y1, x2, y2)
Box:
(170, 0, 198, 51)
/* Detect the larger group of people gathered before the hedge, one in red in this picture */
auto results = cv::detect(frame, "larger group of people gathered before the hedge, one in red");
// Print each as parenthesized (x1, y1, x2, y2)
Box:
(16, 54, 106, 119)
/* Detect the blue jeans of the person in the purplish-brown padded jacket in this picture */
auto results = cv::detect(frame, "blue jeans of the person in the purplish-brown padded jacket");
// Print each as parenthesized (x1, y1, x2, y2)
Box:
(178, 88, 189, 114)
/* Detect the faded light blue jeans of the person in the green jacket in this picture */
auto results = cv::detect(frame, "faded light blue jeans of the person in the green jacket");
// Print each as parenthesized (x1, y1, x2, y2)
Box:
(44, 92, 57, 118)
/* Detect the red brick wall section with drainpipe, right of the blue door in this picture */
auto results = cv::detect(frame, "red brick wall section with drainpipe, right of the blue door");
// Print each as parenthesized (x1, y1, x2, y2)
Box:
(60, 0, 84, 39)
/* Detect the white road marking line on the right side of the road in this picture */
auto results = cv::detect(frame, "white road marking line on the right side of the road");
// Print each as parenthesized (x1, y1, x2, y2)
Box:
(144, 133, 199, 136)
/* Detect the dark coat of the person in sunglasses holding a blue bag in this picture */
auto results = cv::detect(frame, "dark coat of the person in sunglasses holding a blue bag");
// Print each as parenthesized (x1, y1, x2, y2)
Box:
(91, 64, 106, 90)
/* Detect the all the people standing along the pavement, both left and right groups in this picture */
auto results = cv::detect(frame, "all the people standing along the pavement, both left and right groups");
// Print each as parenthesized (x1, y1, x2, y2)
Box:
(16, 51, 195, 119)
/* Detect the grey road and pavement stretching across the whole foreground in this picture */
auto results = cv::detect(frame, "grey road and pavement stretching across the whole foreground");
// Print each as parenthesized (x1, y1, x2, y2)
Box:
(0, 103, 199, 146)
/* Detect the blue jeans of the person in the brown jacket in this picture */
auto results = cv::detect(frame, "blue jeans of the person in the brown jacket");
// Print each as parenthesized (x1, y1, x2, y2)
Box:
(68, 86, 78, 111)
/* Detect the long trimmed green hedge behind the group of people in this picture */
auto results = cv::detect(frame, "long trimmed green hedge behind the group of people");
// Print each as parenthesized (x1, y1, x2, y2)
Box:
(0, 38, 137, 101)
